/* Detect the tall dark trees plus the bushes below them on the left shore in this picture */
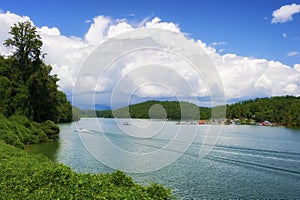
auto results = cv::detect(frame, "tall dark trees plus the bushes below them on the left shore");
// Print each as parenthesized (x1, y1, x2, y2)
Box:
(0, 21, 78, 148)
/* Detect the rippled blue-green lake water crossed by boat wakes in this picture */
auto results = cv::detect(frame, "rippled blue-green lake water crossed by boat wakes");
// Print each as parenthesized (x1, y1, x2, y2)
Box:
(26, 118, 300, 199)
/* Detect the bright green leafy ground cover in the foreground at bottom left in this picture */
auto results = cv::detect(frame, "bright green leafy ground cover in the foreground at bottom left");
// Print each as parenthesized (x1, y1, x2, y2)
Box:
(0, 140, 173, 200)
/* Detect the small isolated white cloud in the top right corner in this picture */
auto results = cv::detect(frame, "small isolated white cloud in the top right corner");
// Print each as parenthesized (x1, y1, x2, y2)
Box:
(272, 3, 300, 24)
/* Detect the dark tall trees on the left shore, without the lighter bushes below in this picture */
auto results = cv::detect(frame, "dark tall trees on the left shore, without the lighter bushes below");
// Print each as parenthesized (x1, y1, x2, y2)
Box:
(0, 21, 73, 123)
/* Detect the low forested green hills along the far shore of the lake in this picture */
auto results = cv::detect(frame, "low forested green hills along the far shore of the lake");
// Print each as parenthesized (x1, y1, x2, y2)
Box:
(92, 96, 300, 126)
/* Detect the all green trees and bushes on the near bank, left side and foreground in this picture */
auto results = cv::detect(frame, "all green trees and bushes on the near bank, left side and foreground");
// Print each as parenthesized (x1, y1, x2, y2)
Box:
(0, 22, 172, 199)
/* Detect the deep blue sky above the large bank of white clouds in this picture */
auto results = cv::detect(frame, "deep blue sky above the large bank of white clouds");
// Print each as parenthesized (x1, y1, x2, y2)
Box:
(0, 0, 300, 66)
